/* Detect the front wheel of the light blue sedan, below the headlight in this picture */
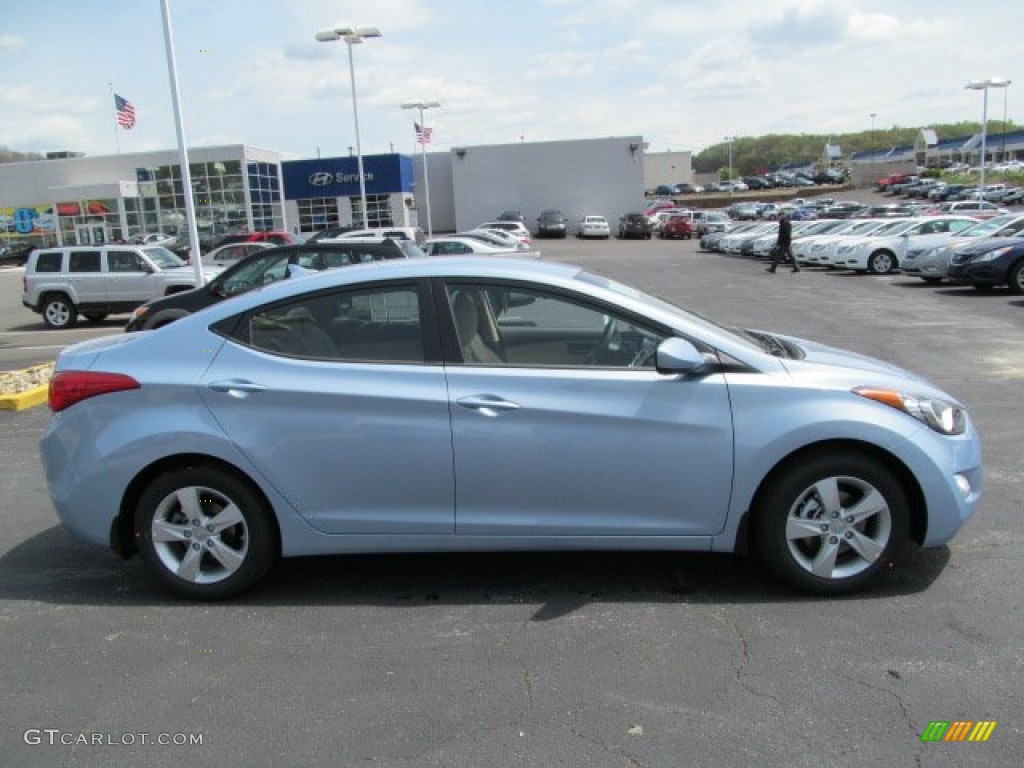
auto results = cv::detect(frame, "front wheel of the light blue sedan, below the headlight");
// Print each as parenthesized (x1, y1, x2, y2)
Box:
(752, 453, 910, 595)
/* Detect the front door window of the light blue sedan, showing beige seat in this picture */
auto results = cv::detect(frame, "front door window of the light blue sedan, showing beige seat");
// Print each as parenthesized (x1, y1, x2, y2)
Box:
(446, 284, 668, 369)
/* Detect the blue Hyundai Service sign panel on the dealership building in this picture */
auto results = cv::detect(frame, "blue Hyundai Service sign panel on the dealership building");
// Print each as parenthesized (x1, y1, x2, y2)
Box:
(281, 155, 413, 200)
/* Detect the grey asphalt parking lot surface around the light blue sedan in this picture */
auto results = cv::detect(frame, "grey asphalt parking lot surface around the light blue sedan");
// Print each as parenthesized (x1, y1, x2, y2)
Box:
(0, 218, 1024, 768)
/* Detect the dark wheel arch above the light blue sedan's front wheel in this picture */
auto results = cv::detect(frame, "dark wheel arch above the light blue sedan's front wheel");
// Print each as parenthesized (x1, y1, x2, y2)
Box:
(736, 439, 928, 553)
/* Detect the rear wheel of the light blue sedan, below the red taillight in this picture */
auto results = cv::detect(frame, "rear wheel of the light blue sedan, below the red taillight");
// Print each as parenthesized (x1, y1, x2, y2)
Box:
(133, 466, 279, 600)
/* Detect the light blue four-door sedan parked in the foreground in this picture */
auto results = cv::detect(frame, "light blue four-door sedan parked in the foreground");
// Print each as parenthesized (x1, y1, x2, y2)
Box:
(41, 257, 982, 599)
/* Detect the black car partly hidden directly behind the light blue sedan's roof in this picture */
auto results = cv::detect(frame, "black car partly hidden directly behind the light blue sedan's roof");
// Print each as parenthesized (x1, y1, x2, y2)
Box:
(125, 239, 426, 333)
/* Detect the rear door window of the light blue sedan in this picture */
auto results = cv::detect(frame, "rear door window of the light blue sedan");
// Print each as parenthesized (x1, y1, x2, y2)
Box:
(242, 286, 426, 362)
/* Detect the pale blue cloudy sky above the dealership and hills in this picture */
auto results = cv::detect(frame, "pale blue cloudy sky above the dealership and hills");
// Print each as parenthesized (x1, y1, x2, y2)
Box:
(0, 0, 1024, 157)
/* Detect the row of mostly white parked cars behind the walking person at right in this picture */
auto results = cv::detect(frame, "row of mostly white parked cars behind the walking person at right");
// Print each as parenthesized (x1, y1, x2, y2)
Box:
(700, 208, 1024, 295)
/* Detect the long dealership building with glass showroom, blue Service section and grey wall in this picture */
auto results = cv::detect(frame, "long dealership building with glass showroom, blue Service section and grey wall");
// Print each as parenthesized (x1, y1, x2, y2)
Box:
(0, 136, 645, 245)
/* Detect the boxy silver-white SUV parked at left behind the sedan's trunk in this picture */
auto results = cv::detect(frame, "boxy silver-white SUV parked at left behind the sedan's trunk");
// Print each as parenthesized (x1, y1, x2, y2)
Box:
(22, 245, 219, 329)
